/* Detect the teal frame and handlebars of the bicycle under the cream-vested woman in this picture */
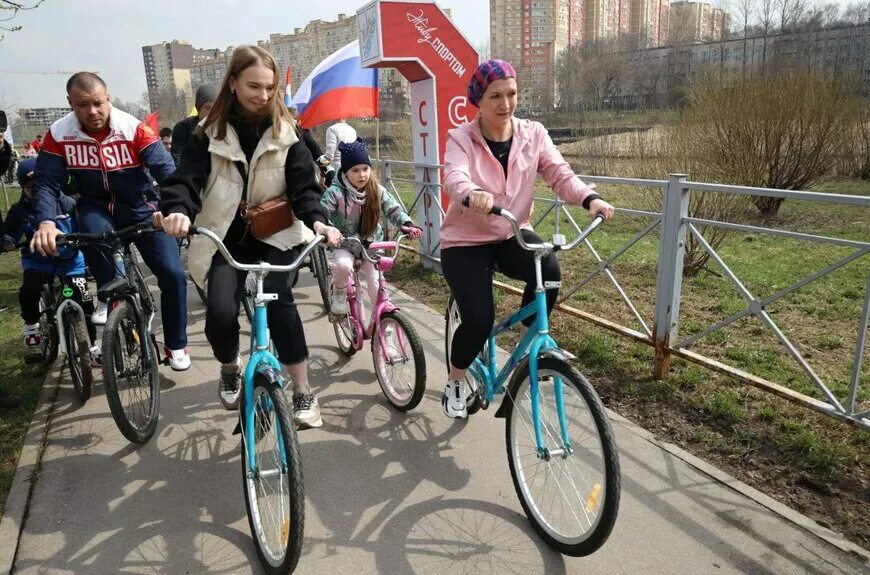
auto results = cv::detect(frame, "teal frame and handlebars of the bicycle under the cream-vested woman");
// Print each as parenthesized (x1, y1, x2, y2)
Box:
(191, 226, 323, 479)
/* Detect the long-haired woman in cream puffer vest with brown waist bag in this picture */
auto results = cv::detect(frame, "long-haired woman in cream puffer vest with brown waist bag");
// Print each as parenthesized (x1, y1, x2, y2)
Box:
(156, 46, 341, 427)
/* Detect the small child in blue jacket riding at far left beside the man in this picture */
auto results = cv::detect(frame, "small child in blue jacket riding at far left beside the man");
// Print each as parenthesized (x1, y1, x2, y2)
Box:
(3, 158, 101, 363)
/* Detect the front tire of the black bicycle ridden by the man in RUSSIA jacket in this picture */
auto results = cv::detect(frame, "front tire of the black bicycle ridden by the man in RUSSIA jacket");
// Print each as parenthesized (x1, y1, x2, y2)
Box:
(103, 301, 160, 443)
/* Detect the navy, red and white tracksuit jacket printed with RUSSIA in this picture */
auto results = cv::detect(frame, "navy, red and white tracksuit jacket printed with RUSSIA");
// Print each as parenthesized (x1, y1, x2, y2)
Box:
(33, 108, 175, 223)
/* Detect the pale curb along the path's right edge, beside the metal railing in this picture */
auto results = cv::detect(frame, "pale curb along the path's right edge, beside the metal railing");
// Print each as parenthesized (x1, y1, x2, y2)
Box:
(390, 285, 870, 565)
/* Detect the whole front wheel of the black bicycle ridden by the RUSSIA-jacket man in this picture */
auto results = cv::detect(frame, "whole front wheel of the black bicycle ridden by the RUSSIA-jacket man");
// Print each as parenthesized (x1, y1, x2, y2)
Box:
(103, 301, 160, 443)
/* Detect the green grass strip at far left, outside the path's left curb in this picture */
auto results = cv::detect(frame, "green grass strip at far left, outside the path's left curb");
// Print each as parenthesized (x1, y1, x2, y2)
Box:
(0, 188, 47, 516)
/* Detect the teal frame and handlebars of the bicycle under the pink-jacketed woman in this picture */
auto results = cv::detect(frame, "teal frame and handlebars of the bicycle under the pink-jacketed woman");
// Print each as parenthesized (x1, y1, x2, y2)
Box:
(468, 207, 603, 459)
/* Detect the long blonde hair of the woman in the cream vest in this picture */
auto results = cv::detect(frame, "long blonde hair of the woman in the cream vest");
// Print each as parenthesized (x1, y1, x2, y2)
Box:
(197, 46, 294, 140)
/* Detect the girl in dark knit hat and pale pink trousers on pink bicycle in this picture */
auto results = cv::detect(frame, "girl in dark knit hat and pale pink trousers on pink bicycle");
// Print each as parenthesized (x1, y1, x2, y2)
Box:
(320, 138, 422, 316)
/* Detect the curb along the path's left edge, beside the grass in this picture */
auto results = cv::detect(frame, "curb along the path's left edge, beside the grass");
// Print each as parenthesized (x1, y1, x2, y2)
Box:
(0, 358, 64, 573)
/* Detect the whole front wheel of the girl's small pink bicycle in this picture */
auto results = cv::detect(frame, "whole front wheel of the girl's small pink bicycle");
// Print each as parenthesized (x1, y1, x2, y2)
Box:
(372, 311, 426, 411)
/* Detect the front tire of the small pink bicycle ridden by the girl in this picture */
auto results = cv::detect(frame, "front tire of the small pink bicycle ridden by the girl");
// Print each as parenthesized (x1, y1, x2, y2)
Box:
(371, 310, 426, 411)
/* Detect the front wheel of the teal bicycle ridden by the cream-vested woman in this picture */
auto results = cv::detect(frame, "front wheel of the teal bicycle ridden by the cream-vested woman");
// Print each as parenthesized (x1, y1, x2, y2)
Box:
(241, 373, 305, 575)
